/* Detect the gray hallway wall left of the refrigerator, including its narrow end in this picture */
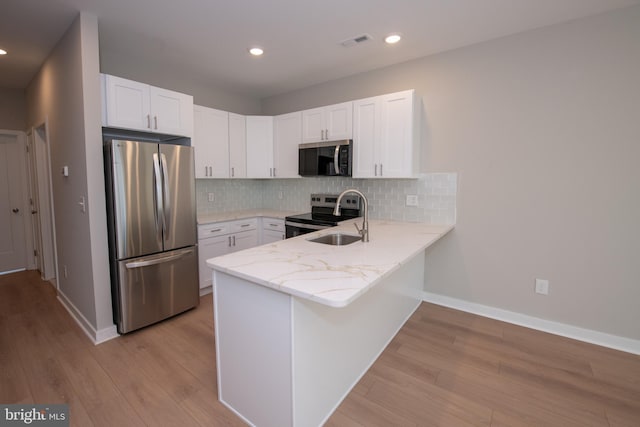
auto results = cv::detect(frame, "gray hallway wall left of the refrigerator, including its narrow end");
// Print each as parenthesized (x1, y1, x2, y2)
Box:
(26, 13, 113, 338)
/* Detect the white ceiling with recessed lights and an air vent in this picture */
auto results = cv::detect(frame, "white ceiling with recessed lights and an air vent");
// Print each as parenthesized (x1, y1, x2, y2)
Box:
(0, 0, 640, 98)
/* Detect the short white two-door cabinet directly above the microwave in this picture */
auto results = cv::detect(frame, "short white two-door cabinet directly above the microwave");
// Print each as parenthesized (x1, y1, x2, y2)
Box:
(302, 102, 353, 142)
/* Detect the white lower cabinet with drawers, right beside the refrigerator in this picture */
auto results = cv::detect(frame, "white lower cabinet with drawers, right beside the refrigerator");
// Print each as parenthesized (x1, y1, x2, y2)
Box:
(198, 218, 259, 294)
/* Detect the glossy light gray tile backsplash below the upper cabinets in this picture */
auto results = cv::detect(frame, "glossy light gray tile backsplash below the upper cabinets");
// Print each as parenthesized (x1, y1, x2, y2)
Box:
(196, 173, 458, 224)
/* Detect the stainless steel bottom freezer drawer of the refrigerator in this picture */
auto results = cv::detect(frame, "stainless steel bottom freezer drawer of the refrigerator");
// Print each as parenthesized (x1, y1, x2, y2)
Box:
(116, 246, 199, 334)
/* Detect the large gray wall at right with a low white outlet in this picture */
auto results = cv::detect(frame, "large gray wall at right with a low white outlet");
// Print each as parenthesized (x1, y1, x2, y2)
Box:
(263, 6, 640, 340)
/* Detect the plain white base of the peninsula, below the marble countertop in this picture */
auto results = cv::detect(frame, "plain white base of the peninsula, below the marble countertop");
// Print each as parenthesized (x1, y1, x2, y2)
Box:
(213, 251, 425, 427)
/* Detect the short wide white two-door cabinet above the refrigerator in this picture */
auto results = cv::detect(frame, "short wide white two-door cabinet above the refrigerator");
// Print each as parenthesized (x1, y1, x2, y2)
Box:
(101, 74, 193, 137)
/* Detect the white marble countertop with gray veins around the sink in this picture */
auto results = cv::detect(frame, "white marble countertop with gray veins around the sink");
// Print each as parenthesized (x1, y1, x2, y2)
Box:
(207, 219, 454, 307)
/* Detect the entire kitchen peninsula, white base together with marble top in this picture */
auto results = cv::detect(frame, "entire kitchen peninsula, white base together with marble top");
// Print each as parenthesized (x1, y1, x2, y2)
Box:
(207, 220, 453, 426)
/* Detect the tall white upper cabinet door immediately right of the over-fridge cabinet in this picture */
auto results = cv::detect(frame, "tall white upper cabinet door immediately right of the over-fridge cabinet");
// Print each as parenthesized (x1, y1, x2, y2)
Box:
(191, 105, 229, 178)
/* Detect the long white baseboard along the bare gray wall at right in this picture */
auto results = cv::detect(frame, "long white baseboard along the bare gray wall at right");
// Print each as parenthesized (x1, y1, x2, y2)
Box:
(422, 292, 640, 355)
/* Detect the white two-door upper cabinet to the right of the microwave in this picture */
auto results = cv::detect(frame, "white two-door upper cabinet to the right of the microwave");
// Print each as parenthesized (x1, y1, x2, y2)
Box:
(353, 90, 420, 178)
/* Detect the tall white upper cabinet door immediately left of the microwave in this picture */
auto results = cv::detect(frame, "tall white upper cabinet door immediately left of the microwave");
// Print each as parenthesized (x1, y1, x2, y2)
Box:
(273, 111, 302, 178)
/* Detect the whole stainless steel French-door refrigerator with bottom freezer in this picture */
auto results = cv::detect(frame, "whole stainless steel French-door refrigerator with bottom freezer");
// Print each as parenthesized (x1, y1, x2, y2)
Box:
(104, 139, 199, 334)
